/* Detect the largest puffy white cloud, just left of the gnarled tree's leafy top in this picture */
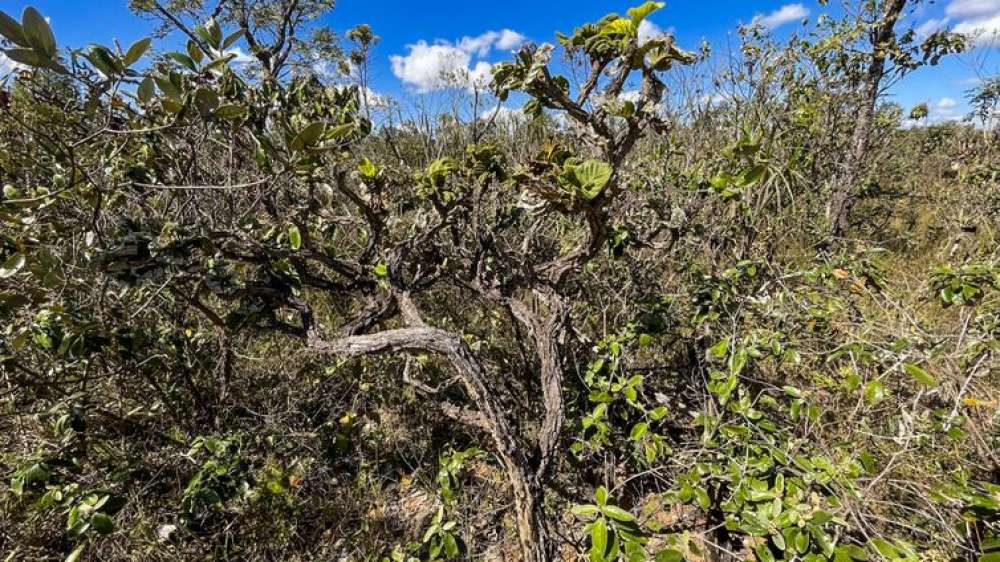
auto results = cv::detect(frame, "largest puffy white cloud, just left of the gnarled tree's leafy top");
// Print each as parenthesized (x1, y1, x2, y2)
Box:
(389, 29, 526, 93)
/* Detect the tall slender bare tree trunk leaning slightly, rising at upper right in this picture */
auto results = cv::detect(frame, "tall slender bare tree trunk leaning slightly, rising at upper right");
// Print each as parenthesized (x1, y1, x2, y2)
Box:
(830, 0, 907, 237)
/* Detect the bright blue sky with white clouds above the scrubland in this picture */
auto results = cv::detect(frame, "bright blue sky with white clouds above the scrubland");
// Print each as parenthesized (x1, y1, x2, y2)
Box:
(0, 0, 1000, 120)
